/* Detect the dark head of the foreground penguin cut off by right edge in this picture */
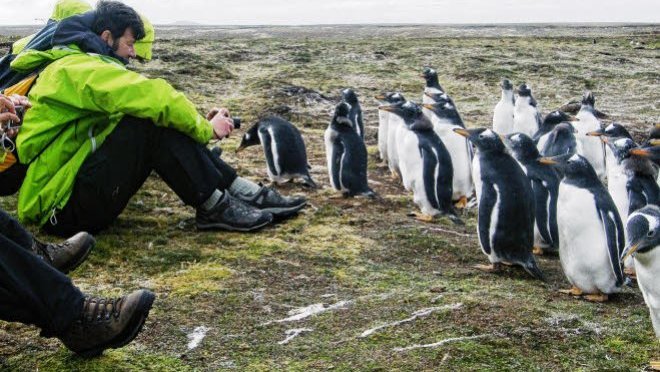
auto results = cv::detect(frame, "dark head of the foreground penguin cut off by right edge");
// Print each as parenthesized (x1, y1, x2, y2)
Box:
(621, 204, 660, 260)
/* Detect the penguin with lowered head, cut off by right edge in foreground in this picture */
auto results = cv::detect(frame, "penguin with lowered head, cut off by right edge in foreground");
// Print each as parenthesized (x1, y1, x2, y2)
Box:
(623, 205, 660, 338)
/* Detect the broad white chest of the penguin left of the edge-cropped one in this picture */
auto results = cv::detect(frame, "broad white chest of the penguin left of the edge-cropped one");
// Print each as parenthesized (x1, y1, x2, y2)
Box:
(557, 182, 617, 293)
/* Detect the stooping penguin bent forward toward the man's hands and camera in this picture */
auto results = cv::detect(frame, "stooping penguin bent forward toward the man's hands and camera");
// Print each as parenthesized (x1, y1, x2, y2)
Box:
(236, 116, 316, 187)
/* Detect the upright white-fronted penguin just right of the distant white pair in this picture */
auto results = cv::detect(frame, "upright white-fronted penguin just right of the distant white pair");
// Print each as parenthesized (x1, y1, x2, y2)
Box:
(574, 91, 607, 182)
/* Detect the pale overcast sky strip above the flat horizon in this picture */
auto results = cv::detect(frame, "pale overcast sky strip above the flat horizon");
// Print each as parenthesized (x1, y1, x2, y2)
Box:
(0, 0, 660, 26)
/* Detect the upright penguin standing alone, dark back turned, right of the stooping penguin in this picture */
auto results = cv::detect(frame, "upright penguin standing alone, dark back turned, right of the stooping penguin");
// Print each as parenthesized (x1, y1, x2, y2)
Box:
(325, 102, 376, 197)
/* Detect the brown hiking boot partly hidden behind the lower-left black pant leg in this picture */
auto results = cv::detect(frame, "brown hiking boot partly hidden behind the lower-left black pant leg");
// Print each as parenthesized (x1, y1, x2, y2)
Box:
(32, 232, 96, 274)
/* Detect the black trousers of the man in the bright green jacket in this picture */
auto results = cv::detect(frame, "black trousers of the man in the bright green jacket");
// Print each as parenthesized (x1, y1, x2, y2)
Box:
(44, 116, 236, 236)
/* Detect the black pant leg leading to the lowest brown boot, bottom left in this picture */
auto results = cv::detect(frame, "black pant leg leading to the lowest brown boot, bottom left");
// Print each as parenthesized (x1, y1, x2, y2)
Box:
(0, 235, 84, 336)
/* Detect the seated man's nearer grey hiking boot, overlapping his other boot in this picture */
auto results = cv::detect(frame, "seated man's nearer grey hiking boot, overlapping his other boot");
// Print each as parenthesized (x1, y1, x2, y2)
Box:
(195, 191, 273, 232)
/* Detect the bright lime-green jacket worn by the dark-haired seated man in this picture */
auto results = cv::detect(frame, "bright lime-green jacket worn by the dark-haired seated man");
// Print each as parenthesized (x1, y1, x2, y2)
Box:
(11, 45, 213, 225)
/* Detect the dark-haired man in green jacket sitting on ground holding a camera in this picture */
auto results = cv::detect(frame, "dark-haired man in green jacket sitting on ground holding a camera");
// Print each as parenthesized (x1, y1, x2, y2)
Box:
(11, 1, 306, 235)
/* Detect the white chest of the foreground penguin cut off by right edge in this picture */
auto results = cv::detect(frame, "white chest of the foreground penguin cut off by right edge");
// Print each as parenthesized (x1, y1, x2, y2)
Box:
(635, 247, 660, 338)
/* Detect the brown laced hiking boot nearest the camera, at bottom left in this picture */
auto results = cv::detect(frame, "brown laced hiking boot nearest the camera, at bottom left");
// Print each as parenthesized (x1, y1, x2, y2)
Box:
(58, 289, 155, 358)
